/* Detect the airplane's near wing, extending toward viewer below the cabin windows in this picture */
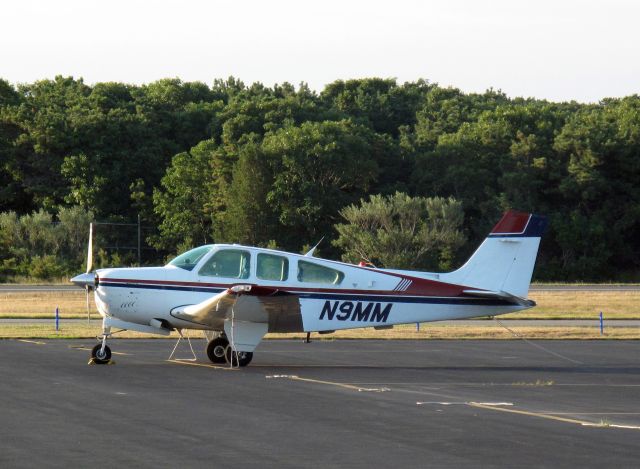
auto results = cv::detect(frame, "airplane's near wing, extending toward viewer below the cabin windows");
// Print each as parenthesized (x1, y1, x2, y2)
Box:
(171, 285, 302, 332)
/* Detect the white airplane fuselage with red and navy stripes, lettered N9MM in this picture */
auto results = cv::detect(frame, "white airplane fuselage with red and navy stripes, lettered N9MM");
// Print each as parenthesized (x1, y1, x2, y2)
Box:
(95, 244, 526, 332)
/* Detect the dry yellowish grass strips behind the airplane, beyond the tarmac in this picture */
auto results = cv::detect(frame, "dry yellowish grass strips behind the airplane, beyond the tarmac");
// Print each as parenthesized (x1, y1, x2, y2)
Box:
(0, 290, 640, 339)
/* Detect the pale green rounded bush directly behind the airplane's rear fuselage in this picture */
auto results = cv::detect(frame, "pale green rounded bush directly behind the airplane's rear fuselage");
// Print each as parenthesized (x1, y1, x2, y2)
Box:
(334, 192, 464, 270)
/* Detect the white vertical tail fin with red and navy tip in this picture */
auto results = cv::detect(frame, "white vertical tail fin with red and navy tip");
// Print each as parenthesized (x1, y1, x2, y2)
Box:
(441, 210, 547, 297)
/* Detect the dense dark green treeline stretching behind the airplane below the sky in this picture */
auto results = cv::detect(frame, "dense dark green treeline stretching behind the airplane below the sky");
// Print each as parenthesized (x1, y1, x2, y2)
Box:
(0, 77, 640, 280)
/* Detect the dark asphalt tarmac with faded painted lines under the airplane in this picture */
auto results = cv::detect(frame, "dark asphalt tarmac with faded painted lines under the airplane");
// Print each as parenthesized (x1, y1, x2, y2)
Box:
(0, 339, 640, 468)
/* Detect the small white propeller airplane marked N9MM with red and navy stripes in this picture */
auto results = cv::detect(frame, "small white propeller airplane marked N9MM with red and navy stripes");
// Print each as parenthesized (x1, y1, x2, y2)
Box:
(71, 211, 547, 367)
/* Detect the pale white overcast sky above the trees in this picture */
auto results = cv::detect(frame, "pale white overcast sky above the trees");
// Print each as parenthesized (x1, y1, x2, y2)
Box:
(0, 0, 640, 102)
